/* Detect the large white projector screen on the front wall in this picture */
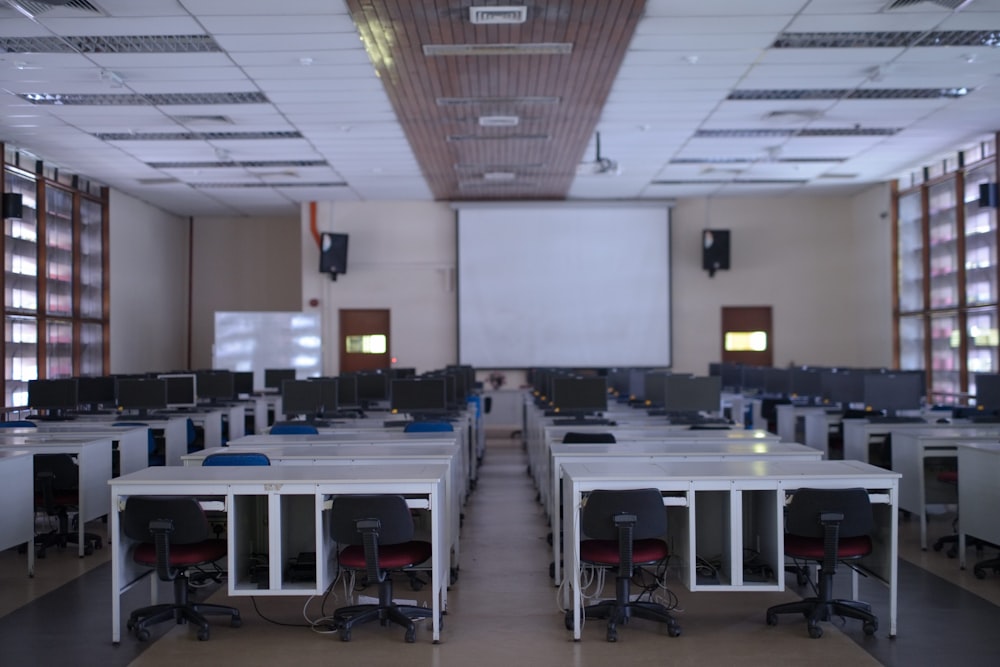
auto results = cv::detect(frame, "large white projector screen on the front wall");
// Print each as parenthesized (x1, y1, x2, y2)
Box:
(456, 202, 671, 368)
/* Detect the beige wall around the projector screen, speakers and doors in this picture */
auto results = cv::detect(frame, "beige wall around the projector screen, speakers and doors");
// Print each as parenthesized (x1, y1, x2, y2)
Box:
(111, 186, 892, 374)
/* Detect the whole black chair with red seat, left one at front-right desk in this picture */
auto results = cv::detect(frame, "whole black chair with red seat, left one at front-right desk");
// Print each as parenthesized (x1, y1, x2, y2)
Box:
(565, 489, 681, 642)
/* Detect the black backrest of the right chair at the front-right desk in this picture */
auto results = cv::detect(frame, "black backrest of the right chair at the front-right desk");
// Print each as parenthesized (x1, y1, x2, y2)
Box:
(785, 488, 875, 538)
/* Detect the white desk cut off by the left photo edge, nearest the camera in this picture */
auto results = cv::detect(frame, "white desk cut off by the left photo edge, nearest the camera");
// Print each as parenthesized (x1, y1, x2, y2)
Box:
(0, 449, 35, 577)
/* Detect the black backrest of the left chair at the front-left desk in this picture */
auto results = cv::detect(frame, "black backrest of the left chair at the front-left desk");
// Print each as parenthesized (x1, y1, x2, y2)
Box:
(121, 496, 212, 544)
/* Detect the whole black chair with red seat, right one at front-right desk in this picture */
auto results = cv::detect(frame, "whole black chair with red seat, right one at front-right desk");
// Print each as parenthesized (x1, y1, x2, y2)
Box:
(766, 488, 878, 639)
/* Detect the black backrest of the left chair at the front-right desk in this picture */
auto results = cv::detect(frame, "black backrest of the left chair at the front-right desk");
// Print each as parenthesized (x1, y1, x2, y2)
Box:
(580, 489, 667, 540)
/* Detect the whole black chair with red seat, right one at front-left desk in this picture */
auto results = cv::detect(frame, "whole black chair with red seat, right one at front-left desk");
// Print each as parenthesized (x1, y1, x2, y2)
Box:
(330, 495, 433, 642)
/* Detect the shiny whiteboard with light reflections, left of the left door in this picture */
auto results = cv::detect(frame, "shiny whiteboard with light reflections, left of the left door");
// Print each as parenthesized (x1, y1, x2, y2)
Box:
(212, 311, 323, 391)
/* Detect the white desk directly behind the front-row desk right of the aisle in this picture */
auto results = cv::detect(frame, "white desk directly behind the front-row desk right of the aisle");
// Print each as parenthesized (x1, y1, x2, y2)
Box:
(547, 439, 822, 586)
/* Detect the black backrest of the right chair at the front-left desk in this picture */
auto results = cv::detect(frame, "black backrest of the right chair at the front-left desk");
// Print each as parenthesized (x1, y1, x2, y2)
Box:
(330, 495, 413, 545)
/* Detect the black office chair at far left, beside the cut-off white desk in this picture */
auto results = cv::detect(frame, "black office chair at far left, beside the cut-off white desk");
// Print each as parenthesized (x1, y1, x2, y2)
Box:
(34, 454, 104, 558)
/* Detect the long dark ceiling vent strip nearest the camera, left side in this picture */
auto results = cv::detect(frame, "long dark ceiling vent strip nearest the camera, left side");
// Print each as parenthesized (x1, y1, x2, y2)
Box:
(0, 35, 222, 53)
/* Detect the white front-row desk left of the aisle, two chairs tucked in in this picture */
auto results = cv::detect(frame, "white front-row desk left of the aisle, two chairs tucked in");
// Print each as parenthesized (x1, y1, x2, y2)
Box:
(110, 465, 448, 644)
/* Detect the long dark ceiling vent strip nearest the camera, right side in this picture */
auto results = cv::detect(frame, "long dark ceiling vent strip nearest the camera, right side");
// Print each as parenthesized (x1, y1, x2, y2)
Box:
(771, 30, 1000, 49)
